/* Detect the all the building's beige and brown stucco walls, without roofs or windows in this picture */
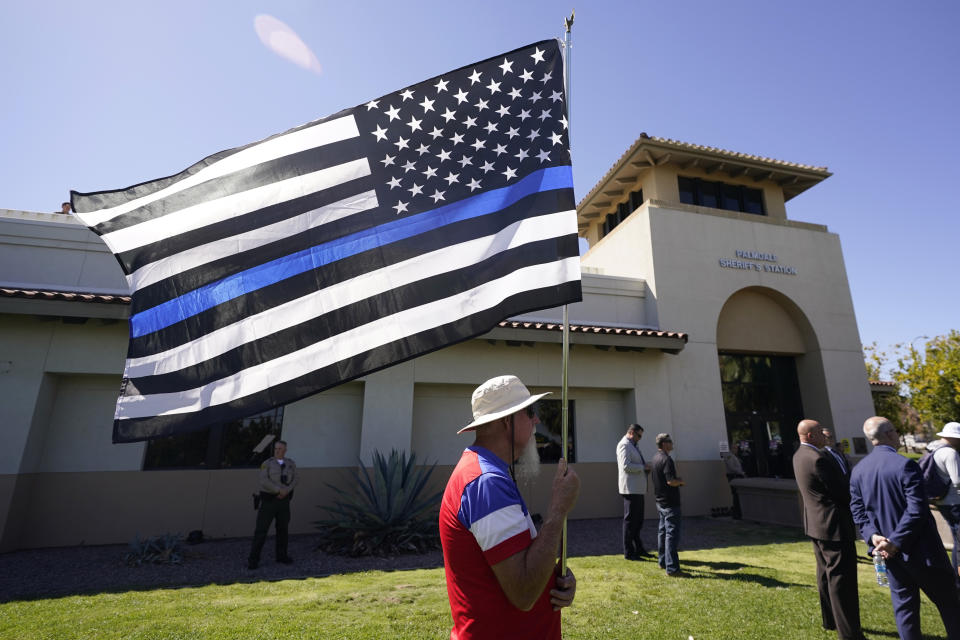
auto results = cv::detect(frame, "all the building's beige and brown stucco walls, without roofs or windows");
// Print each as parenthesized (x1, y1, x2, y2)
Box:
(0, 198, 872, 549)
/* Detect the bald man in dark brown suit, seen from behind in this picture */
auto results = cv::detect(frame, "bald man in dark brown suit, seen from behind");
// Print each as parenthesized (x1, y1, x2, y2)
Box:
(793, 420, 863, 640)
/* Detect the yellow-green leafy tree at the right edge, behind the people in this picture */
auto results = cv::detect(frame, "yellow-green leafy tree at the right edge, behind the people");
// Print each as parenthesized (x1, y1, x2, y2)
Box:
(895, 329, 960, 427)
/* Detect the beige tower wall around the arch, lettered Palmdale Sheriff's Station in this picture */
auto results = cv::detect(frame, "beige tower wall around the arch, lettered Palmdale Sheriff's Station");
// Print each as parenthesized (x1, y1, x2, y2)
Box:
(583, 203, 872, 448)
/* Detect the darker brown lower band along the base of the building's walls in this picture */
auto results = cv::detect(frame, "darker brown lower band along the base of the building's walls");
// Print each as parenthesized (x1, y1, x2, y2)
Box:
(0, 461, 730, 551)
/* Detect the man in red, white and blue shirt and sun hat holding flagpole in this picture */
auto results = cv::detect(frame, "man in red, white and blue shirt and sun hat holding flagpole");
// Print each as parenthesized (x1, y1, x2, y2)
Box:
(440, 375, 580, 640)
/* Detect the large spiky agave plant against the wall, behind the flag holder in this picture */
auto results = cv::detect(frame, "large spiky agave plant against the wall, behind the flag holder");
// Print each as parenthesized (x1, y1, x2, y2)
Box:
(314, 449, 442, 556)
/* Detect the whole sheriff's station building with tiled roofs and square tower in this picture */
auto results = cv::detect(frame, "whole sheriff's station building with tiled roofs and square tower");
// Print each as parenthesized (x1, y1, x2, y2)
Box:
(0, 135, 873, 551)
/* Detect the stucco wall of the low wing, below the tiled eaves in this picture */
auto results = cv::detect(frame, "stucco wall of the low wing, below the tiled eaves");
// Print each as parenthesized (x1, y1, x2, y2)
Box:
(0, 304, 712, 550)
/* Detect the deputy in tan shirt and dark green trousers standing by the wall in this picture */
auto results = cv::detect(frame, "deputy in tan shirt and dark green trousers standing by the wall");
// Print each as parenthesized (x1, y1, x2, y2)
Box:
(247, 440, 297, 569)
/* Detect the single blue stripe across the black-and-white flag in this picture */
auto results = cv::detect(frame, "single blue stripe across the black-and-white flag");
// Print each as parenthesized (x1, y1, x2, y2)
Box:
(130, 165, 573, 338)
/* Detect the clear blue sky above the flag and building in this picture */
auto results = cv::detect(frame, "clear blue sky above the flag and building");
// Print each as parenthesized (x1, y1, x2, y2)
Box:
(0, 0, 960, 364)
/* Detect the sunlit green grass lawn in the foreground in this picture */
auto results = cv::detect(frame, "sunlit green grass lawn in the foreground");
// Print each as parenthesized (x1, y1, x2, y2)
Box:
(0, 529, 945, 640)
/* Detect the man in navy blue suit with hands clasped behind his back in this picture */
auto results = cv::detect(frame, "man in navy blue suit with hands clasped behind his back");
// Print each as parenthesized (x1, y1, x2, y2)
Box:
(850, 416, 960, 640)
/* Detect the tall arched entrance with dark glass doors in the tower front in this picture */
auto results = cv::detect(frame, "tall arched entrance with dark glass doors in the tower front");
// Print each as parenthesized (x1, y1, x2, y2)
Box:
(717, 287, 822, 478)
